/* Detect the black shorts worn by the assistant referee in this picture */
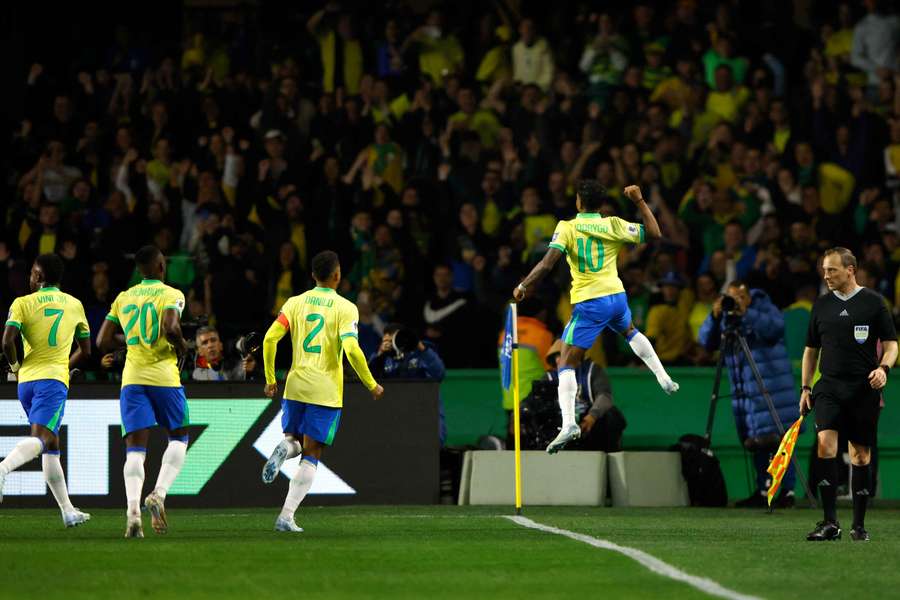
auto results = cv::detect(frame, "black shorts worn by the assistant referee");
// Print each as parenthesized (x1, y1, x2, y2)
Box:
(812, 375, 881, 447)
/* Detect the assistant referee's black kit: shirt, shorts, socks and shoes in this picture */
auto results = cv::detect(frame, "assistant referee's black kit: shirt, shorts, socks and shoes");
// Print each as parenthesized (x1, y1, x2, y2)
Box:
(806, 287, 897, 540)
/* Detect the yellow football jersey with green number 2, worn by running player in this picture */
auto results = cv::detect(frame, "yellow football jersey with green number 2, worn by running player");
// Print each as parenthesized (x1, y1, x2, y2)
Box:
(278, 287, 359, 408)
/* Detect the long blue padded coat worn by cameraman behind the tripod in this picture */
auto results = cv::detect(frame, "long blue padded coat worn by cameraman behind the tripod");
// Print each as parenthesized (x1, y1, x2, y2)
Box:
(699, 289, 800, 442)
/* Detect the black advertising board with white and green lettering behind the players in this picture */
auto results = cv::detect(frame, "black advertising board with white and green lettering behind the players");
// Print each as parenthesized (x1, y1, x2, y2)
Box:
(0, 382, 440, 508)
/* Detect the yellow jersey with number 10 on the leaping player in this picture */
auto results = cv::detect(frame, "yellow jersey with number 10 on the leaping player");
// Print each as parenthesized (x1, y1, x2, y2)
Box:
(550, 213, 644, 304)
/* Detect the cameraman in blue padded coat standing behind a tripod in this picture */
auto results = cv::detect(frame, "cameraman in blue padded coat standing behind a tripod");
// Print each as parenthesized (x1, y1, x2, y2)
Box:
(698, 281, 800, 508)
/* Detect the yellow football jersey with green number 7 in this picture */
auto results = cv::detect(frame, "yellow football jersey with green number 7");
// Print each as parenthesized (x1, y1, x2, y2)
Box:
(6, 287, 91, 386)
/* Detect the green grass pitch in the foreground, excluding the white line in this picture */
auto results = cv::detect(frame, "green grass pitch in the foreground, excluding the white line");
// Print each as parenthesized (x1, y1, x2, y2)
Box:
(0, 502, 900, 600)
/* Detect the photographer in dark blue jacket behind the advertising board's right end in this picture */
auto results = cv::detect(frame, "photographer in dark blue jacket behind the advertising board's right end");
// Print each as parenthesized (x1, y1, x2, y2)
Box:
(369, 323, 447, 447)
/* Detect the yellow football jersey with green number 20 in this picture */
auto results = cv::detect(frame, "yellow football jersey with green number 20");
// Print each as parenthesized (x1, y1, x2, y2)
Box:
(106, 279, 184, 387)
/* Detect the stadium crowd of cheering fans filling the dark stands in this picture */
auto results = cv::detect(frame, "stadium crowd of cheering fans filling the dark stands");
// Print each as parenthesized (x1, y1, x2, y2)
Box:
(0, 0, 900, 376)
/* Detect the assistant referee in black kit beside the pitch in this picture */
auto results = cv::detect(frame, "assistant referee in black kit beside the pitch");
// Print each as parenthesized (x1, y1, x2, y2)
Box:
(800, 248, 897, 541)
